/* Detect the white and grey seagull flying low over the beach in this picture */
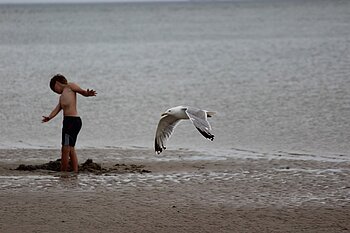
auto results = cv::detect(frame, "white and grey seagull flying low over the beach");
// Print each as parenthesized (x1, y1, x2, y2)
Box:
(154, 106, 215, 154)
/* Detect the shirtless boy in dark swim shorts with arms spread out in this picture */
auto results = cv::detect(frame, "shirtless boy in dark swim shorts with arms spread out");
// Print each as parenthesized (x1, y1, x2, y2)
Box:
(42, 74, 97, 172)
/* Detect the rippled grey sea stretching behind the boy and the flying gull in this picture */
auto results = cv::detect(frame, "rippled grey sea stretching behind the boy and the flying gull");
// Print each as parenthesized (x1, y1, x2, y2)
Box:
(0, 1, 350, 157)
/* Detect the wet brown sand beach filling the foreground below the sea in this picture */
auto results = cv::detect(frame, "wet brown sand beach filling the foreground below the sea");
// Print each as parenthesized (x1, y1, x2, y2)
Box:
(0, 149, 350, 233)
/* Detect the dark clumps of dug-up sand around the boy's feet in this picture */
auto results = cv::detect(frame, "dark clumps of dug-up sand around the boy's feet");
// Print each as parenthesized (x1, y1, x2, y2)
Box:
(15, 159, 151, 175)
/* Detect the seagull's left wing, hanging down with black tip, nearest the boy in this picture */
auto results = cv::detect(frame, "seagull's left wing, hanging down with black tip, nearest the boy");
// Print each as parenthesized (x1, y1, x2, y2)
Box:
(154, 115, 180, 154)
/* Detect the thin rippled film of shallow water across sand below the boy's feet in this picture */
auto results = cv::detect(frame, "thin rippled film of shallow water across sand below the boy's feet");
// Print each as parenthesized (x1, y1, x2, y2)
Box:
(0, 167, 350, 206)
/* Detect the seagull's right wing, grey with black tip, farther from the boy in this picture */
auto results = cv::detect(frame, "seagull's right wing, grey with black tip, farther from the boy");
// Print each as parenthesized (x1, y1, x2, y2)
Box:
(185, 108, 214, 141)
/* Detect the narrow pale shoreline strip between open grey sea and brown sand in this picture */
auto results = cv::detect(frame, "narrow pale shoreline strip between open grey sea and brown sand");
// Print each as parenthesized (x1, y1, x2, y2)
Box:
(0, 146, 350, 163)
